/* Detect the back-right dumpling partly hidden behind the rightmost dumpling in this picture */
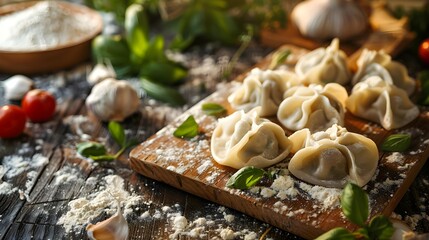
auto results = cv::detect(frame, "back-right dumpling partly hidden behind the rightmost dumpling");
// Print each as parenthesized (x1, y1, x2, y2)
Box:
(352, 49, 416, 96)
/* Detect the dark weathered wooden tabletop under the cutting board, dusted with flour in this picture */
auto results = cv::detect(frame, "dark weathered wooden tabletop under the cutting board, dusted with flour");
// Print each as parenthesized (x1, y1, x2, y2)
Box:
(0, 42, 429, 239)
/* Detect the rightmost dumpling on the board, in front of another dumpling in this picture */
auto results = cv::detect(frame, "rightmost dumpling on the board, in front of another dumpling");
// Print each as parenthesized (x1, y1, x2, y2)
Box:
(346, 76, 419, 130)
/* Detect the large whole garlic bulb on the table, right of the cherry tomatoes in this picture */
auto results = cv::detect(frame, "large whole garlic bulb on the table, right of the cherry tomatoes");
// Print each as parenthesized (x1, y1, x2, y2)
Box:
(86, 78, 140, 121)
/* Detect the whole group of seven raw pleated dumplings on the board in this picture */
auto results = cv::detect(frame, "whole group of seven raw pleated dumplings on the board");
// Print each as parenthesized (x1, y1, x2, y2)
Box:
(211, 39, 419, 188)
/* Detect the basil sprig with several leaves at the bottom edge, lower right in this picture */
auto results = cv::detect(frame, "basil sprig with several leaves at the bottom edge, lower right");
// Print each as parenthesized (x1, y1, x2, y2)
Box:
(316, 183, 395, 240)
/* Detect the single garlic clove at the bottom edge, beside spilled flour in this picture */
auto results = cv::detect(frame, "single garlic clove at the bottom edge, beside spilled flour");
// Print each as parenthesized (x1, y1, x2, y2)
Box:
(86, 200, 129, 240)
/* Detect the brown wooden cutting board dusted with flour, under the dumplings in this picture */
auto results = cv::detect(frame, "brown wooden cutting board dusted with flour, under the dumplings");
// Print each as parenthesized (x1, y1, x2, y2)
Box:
(130, 46, 429, 239)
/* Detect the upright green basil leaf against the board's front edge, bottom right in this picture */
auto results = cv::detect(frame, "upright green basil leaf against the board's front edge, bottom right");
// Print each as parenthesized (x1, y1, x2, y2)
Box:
(341, 183, 369, 227)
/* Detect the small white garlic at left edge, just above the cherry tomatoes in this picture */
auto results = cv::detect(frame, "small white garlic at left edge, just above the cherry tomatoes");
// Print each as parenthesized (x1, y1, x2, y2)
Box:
(3, 75, 34, 100)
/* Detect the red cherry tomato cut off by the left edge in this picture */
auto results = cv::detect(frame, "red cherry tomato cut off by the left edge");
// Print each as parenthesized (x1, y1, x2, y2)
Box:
(0, 105, 27, 138)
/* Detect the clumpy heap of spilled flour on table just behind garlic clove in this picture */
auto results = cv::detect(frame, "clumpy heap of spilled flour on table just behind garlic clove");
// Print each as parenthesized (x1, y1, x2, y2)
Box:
(58, 175, 141, 232)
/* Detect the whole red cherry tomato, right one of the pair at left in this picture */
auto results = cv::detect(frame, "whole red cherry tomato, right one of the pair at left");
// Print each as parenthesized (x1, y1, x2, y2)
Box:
(21, 89, 57, 122)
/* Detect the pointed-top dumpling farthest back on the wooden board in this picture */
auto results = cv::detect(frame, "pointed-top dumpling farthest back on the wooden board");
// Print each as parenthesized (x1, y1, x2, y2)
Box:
(295, 38, 351, 85)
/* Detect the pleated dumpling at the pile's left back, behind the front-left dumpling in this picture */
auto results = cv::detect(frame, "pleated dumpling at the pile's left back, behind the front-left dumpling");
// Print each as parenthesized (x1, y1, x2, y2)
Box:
(228, 68, 299, 117)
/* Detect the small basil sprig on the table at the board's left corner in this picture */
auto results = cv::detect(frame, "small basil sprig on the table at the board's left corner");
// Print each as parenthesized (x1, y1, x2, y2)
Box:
(76, 121, 138, 161)
